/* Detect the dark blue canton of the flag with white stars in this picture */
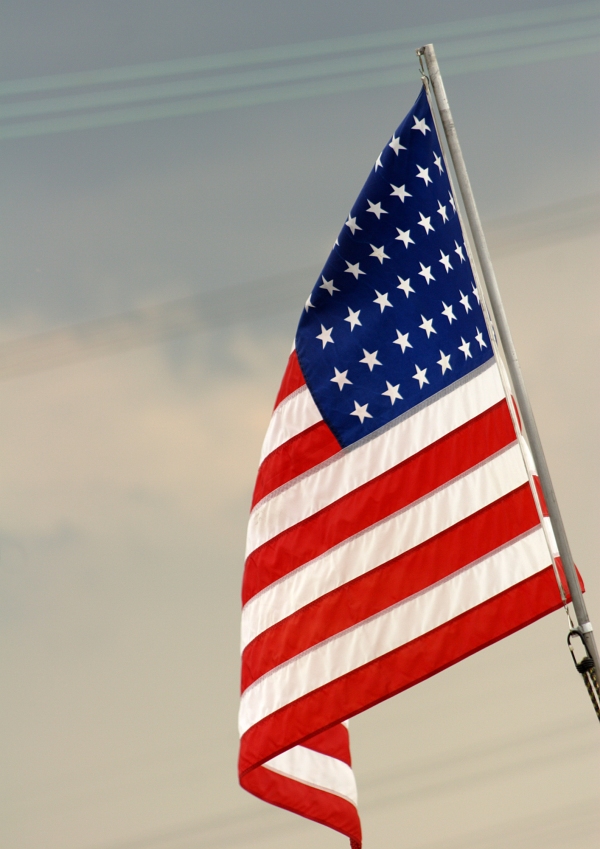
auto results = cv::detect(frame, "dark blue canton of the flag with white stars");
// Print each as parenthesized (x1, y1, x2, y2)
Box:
(296, 84, 493, 446)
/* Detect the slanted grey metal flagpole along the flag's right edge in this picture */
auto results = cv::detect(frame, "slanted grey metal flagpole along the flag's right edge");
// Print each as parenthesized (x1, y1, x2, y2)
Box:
(417, 44, 600, 673)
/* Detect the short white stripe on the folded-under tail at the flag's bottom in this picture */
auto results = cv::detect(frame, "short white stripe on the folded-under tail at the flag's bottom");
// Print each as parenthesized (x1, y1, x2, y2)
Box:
(263, 746, 358, 805)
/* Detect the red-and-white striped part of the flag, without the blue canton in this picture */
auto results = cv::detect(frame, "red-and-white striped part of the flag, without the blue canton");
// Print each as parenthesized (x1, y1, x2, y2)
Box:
(240, 352, 572, 846)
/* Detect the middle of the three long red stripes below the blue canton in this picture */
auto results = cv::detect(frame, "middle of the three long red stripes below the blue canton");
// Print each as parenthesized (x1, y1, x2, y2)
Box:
(242, 483, 539, 690)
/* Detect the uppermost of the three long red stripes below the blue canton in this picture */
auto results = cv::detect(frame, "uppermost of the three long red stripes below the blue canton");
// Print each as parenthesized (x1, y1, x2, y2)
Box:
(242, 400, 515, 604)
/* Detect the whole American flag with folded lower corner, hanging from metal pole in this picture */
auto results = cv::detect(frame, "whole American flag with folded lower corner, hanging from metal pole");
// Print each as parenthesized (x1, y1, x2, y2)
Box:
(239, 89, 562, 847)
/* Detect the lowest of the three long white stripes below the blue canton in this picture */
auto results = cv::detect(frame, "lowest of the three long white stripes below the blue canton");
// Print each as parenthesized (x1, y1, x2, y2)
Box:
(239, 527, 550, 734)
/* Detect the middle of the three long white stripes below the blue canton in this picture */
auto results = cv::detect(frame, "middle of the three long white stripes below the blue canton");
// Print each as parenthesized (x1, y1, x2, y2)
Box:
(242, 443, 527, 650)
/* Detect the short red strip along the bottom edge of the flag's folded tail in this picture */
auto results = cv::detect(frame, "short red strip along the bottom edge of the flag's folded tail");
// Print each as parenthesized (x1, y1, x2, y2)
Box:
(240, 767, 362, 849)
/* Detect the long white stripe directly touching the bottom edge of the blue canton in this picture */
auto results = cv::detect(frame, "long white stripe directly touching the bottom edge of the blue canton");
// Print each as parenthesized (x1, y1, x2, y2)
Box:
(246, 363, 504, 556)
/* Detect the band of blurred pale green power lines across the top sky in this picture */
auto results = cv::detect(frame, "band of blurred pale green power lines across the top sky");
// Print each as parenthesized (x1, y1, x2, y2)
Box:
(0, 2, 600, 139)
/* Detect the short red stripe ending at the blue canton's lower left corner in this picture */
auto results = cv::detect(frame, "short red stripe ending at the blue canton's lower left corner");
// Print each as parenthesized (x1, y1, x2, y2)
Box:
(252, 421, 341, 507)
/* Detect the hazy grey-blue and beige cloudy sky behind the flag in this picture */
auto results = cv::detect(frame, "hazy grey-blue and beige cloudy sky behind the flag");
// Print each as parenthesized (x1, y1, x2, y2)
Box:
(0, 0, 600, 849)
